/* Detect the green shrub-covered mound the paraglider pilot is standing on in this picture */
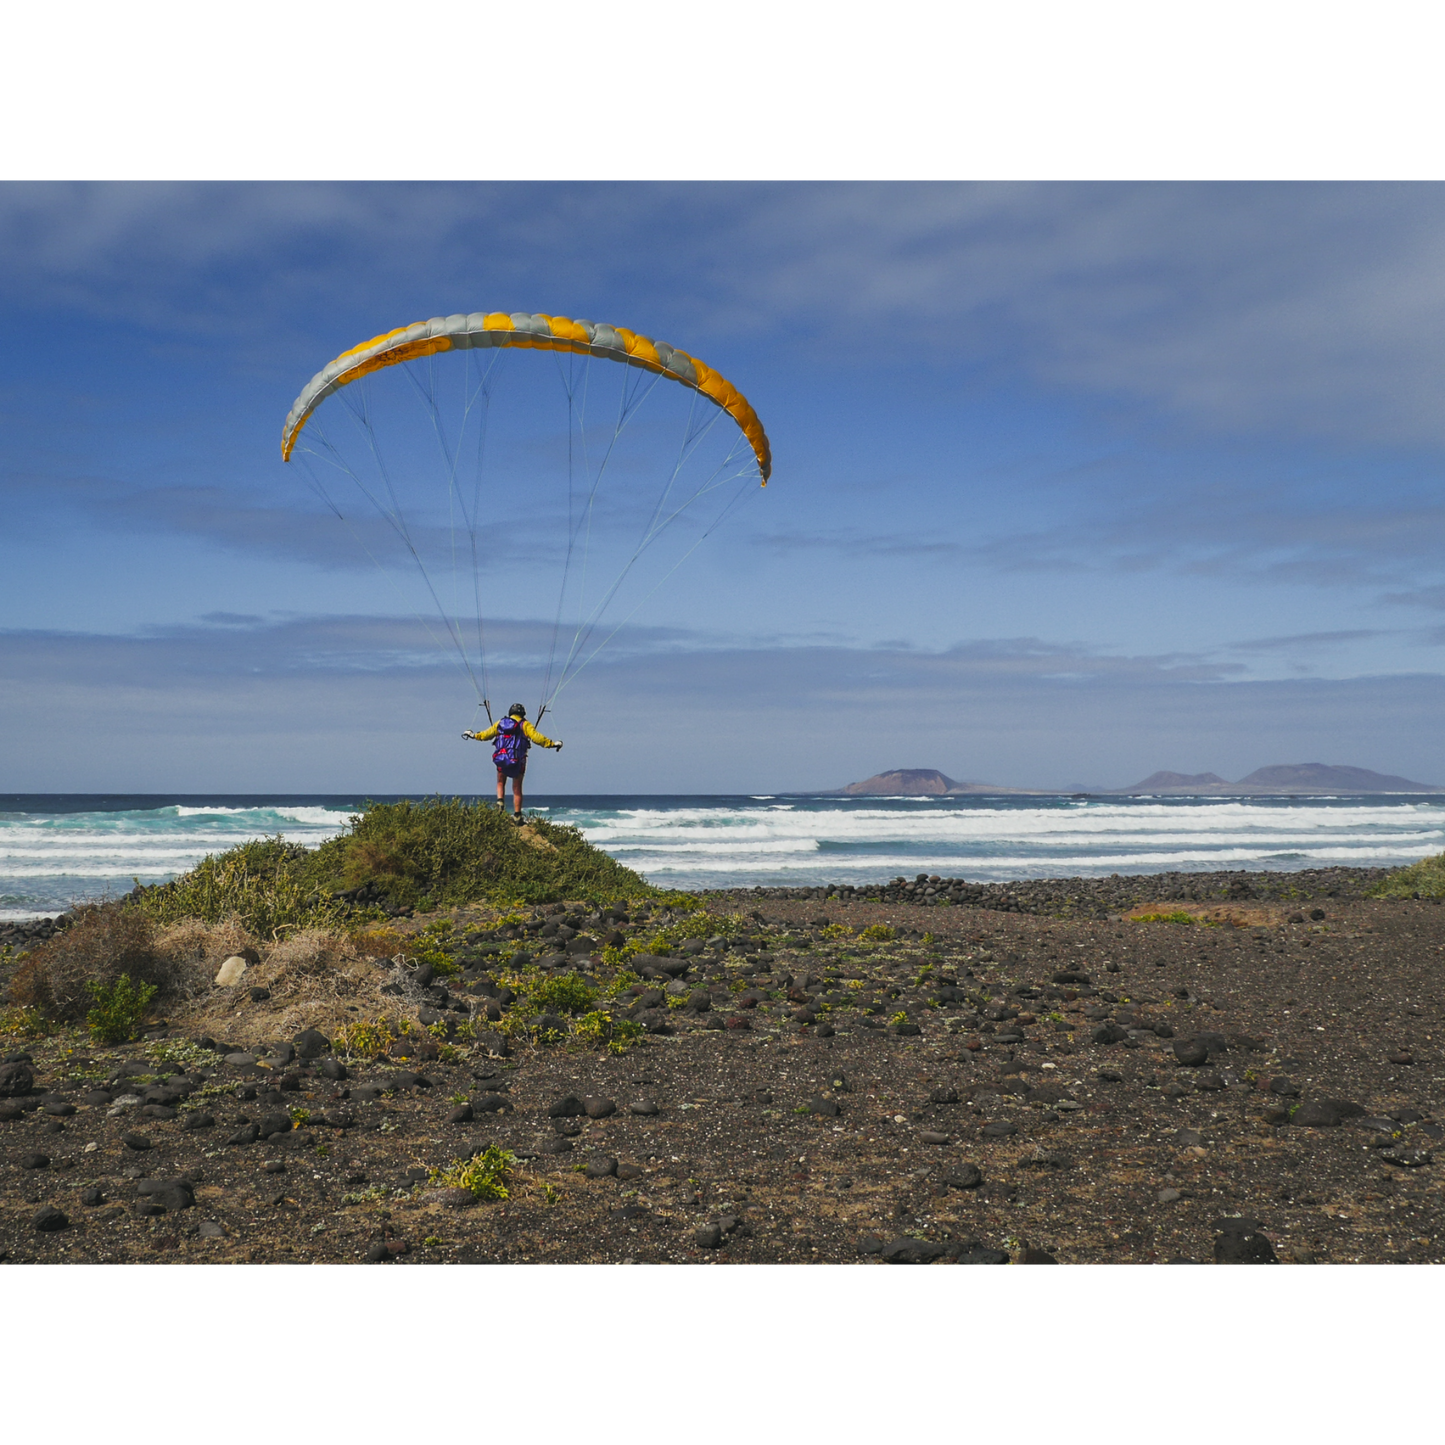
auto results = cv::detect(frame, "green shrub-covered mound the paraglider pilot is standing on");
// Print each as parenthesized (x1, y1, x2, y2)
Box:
(136, 798, 657, 938)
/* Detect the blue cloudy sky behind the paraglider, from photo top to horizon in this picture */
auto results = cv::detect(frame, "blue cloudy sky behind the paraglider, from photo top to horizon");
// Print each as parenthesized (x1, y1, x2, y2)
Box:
(0, 181, 1445, 792)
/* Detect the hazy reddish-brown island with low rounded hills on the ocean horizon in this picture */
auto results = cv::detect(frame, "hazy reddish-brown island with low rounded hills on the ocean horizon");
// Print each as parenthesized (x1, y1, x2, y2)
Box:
(811, 763, 1445, 798)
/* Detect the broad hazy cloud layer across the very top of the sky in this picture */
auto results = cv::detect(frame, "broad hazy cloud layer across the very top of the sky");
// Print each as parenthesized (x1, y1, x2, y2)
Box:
(8, 179, 1445, 448)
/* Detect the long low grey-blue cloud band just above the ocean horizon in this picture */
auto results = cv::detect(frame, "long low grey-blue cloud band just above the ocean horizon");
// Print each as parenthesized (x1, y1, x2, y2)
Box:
(0, 617, 1445, 792)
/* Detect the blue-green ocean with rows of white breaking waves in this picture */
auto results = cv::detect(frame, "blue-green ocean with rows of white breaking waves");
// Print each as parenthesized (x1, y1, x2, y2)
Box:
(0, 793, 1445, 919)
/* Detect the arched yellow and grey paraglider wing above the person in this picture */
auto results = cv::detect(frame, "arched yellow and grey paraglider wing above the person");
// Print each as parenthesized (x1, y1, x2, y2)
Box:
(280, 311, 773, 487)
